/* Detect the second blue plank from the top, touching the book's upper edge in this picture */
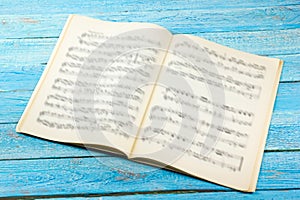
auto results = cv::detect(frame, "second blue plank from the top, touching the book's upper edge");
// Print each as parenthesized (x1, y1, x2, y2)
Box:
(0, 5, 300, 39)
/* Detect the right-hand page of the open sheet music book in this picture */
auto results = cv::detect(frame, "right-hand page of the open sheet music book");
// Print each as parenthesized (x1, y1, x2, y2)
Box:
(134, 35, 282, 192)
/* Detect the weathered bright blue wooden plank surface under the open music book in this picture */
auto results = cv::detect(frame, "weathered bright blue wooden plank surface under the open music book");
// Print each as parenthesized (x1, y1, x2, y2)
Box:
(0, 0, 300, 199)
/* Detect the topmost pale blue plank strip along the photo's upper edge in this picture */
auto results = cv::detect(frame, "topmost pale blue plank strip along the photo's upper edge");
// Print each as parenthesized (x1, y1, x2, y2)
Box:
(0, 0, 297, 15)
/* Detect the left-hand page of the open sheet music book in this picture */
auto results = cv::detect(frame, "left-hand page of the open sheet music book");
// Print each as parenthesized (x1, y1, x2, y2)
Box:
(17, 15, 171, 154)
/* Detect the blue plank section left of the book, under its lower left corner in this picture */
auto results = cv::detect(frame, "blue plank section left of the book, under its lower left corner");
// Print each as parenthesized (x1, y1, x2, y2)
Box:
(0, 124, 106, 161)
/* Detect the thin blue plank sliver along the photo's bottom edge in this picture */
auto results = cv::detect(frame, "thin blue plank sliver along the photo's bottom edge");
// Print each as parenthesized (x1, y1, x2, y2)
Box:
(45, 189, 300, 200)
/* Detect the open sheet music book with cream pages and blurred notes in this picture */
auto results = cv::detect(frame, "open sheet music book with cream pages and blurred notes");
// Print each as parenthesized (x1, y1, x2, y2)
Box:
(17, 15, 282, 192)
